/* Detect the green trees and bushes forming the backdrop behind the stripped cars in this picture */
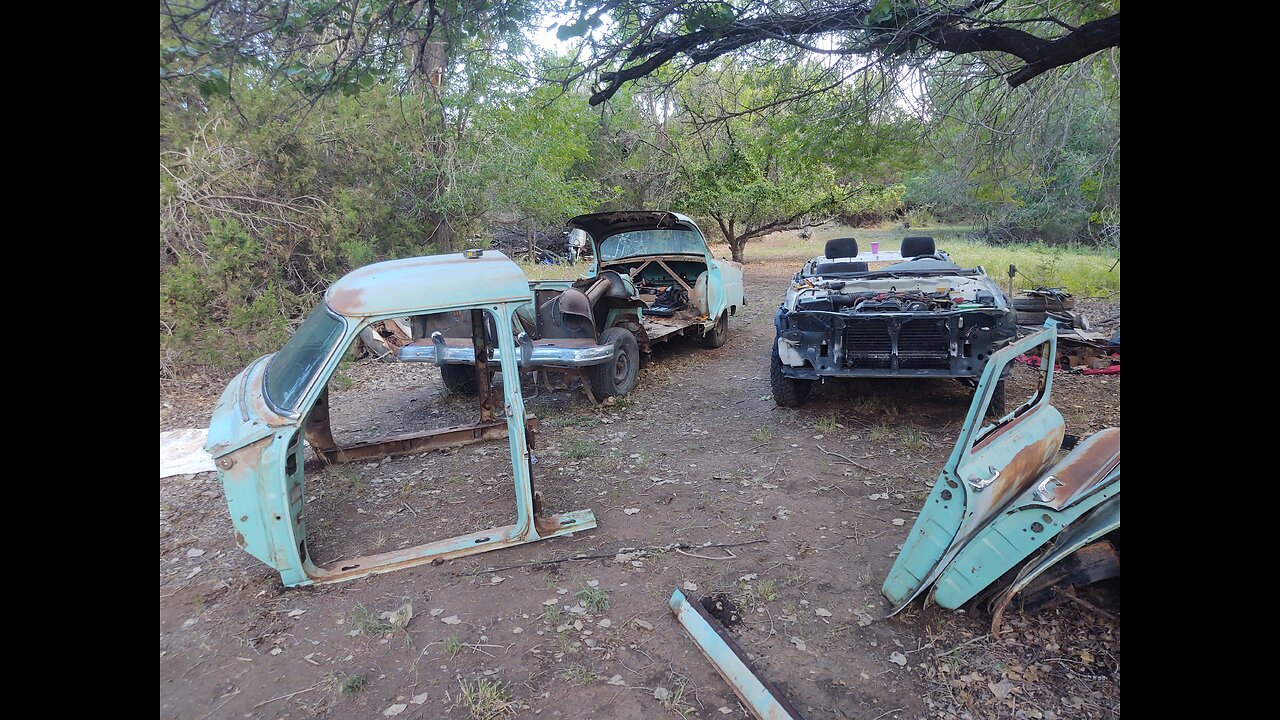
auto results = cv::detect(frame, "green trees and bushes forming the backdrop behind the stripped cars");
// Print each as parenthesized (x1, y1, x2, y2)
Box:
(159, 0, 1120, 376)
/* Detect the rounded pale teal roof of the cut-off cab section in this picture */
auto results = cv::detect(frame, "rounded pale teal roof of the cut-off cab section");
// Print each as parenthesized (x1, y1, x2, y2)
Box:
(325, 250, 529, 318)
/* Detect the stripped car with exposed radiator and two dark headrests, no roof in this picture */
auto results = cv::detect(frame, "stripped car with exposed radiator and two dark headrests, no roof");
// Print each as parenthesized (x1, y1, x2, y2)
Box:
(771, 237, 1018, 407)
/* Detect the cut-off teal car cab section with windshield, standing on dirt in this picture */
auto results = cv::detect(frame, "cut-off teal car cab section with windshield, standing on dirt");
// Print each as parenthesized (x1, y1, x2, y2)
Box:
(205, 251, 595, 587)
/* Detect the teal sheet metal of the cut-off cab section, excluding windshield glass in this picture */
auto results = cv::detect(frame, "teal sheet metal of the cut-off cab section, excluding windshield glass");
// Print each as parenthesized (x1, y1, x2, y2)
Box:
(206, 251, 595, 587)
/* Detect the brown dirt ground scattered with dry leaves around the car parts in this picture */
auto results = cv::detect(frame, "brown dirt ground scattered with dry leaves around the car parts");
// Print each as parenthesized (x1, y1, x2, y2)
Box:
(160, 254, 1120, 720)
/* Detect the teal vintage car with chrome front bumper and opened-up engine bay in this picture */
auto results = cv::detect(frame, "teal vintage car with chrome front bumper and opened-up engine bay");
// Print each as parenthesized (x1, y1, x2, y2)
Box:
(399, 210, 744, 398)
